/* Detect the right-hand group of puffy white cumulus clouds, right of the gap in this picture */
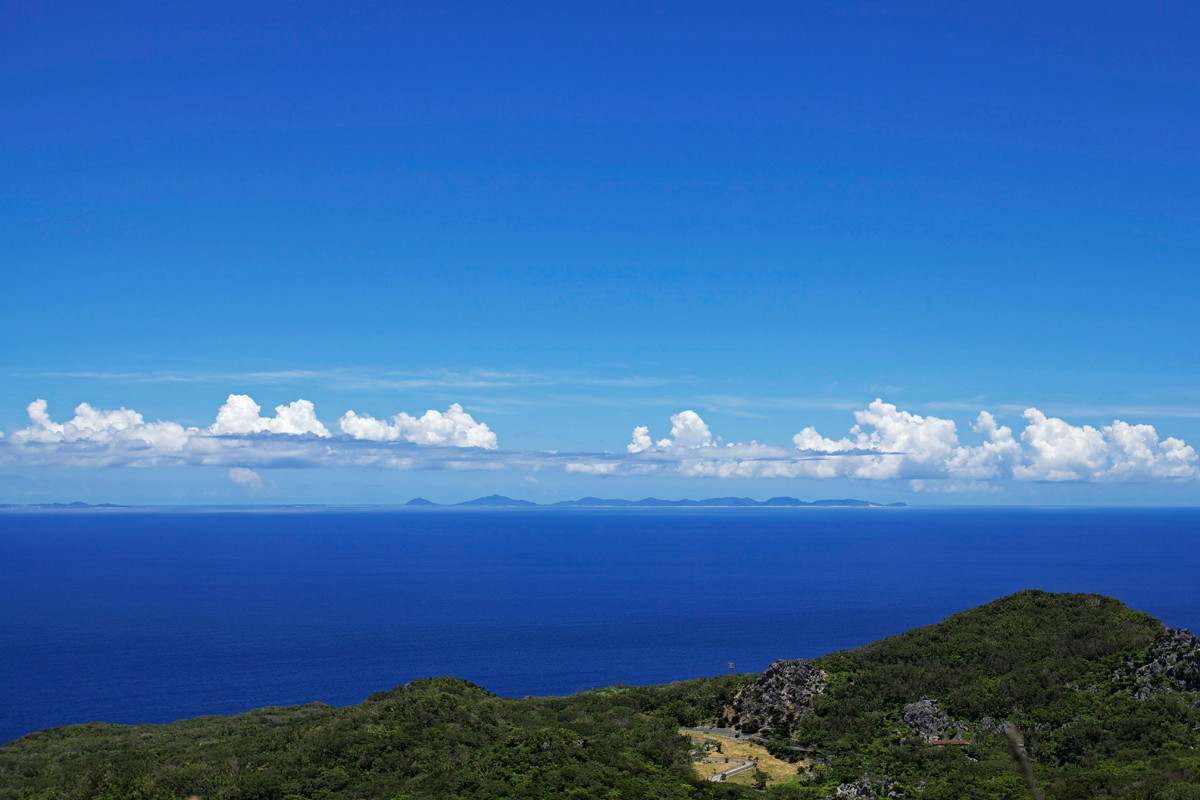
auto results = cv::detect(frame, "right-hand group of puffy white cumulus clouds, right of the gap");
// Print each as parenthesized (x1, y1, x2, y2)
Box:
(614, 398, 1200, 484)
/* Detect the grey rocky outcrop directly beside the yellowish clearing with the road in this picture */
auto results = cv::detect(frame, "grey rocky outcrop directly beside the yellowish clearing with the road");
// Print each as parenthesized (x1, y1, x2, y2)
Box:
(727, 658, 826, 734)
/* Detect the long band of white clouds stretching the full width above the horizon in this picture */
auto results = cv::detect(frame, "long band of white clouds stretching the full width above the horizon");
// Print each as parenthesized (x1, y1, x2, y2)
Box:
(0, 393, 1200, 491)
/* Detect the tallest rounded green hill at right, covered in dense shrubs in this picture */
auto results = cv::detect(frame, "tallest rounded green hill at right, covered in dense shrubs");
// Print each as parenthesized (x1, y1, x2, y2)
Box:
(787, 591, 1200, 799)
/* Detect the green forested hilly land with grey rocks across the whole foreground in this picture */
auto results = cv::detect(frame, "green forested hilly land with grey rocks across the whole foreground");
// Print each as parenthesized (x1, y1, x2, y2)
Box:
(0, 591, 1200, 800)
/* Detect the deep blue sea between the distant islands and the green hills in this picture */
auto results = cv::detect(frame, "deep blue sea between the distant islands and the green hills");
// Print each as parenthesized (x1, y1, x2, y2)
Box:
(0, 509, 1200, 742)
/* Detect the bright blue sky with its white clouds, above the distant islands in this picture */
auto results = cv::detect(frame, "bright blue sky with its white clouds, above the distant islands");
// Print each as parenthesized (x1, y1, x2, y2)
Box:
(0, 2, 1200, 505)
